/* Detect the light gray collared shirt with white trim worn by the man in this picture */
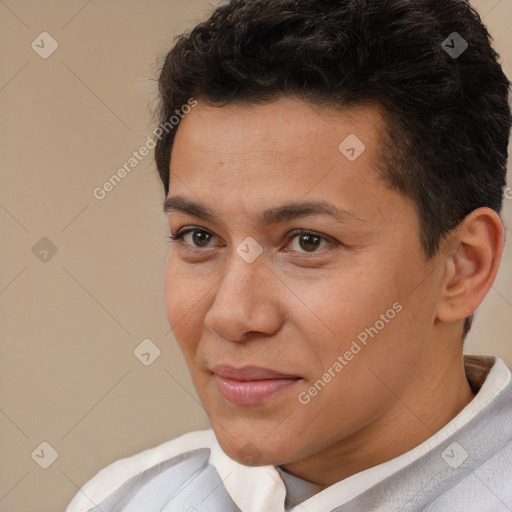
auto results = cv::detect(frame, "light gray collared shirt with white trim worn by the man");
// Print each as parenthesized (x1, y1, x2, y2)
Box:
(66, 356, 512, 512)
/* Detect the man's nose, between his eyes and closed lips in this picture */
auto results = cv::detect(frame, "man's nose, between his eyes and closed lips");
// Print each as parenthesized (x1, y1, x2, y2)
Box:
(204, 255, 283, 342)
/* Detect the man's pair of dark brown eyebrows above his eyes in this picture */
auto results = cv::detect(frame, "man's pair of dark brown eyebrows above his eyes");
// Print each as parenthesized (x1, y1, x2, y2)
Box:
(164, 196, 365, 225)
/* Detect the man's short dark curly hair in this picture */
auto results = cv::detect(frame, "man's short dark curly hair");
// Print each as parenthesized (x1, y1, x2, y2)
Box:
(155, 0, 511, 335)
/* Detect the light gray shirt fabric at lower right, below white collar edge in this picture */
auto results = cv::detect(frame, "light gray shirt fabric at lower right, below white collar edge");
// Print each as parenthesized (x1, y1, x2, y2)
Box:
(333, 366, 512, 512)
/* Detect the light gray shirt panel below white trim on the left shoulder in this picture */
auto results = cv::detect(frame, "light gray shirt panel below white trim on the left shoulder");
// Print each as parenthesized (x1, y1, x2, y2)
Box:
(89, 448, 240, 512)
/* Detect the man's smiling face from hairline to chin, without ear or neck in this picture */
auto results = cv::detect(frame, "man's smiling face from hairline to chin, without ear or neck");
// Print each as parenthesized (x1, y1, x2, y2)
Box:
(165, 98, 439, 465)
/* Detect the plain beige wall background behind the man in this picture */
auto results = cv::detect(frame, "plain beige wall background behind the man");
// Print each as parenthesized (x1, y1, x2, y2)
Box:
(0, 0, 512, 512)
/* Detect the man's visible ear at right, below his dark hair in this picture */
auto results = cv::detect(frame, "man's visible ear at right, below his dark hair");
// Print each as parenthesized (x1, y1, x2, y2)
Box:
(437, 208, 504, 322)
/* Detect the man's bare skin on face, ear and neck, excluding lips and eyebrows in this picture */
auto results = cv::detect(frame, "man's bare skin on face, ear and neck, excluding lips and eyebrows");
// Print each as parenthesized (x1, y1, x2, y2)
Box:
(165, 98, 503, 487)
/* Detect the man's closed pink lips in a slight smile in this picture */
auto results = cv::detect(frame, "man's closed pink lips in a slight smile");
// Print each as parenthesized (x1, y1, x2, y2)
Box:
(211, 365, 301, 406)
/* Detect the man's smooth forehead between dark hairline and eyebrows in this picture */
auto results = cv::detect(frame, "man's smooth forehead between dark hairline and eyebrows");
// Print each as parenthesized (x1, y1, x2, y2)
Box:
(169, 98, 394, 223)
